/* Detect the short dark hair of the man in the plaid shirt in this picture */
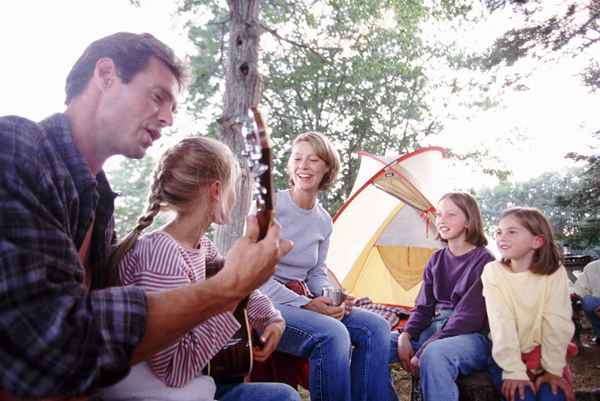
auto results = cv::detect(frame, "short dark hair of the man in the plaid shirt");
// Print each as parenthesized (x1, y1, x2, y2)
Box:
(65, 32, 184, 104)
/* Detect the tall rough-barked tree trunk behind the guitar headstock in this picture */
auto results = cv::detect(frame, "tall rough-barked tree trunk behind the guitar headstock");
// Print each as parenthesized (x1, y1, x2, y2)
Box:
(215, 0, 262, 254)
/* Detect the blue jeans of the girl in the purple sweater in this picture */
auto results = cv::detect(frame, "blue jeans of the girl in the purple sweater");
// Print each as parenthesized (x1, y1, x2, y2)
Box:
(390, 310, 492, 401)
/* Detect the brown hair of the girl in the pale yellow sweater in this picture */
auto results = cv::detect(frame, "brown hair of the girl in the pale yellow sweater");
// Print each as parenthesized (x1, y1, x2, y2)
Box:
(498, 207, 562, 275)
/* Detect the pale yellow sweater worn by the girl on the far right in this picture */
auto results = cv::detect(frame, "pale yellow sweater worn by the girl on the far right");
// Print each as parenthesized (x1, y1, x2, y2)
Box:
(481, 262, 575, 380)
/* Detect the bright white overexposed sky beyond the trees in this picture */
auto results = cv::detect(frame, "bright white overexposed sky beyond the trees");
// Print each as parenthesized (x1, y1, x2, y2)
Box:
(0, 0, 600, 186)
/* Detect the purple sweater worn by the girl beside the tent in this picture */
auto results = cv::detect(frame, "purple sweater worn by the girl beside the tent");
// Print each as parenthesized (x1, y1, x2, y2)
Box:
(404, 247, 494, 356)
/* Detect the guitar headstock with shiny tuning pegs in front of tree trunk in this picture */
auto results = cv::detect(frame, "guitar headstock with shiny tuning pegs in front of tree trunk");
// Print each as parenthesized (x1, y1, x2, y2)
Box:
(241, 107, 274, 240)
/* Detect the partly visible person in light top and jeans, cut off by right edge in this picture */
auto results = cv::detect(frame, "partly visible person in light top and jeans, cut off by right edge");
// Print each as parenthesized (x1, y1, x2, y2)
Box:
(573, 260, 600, 345)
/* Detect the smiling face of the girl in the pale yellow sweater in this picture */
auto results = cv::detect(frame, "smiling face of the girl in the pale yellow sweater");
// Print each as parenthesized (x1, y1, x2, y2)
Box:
(496, 215, 544, 261)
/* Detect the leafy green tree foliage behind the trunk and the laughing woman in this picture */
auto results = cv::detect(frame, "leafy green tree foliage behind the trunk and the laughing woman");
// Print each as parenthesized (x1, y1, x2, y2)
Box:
(181, 0, 471, 213)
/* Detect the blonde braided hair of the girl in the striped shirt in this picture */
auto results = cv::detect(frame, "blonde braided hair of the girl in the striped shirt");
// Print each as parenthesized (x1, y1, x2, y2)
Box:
(108, 136, 239, 268)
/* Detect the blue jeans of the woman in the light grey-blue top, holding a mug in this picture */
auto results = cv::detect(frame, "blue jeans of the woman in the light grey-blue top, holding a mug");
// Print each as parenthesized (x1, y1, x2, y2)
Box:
(276, 305, 397, 401)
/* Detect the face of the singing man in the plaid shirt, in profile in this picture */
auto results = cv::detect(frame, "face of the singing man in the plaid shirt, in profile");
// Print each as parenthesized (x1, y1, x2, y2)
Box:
(95, 58, 179, 159)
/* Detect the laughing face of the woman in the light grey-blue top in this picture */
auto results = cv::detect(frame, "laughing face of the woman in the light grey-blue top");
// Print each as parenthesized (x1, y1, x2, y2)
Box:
(288, 141, 329, 193)
